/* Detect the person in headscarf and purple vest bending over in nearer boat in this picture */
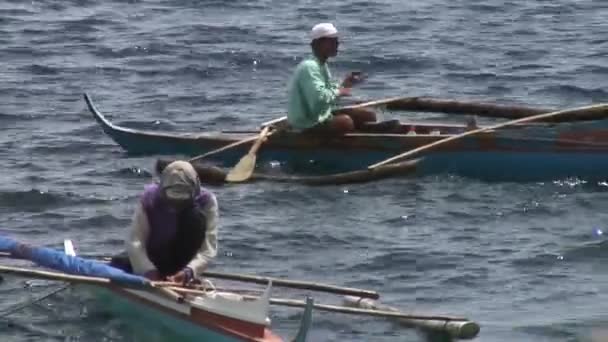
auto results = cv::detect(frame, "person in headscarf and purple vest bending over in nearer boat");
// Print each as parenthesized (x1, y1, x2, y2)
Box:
(111, 161, 219, 283)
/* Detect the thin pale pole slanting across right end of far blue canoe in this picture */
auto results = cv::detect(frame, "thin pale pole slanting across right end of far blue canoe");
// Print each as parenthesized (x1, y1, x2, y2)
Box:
(368, 104, 608, 169)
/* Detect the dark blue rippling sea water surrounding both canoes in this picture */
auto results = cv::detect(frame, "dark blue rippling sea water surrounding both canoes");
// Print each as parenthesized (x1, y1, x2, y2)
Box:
(0, 0, 608, 342)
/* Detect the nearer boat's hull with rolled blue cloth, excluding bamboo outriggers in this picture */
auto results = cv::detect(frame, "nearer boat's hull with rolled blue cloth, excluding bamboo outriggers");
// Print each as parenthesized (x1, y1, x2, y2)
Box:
(0, 237, 313, 342)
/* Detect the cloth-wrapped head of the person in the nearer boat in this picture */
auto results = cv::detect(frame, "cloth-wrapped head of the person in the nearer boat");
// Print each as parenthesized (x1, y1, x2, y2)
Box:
(160, 160, 200, 208)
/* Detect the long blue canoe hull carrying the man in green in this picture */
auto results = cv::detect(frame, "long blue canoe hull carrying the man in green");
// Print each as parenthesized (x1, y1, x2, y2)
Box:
(84, 94, 608, 181)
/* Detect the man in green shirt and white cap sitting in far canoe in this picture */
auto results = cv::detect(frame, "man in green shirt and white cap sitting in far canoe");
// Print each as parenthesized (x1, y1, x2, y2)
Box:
(287, 23, 376, 134)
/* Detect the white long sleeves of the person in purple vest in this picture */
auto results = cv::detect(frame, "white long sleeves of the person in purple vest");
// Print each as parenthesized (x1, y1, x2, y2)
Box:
(126, 195, 219, 277)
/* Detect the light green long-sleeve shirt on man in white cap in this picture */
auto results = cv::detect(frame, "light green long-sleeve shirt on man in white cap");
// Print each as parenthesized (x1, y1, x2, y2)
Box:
(287, 57, 339, 130)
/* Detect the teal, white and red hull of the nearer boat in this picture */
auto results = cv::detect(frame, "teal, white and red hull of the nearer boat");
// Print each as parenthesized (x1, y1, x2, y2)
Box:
(58, 240, 314, 342)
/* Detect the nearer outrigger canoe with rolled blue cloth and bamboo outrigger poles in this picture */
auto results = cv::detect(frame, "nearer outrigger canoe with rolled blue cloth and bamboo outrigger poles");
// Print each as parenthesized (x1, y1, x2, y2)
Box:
(0, 236, 480, 342)
